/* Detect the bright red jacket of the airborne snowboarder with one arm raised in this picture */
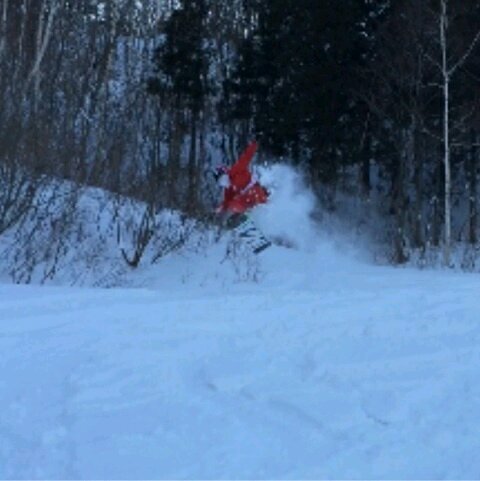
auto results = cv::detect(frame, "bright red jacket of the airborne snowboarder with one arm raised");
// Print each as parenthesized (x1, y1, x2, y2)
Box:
(220, 141, 268, 214)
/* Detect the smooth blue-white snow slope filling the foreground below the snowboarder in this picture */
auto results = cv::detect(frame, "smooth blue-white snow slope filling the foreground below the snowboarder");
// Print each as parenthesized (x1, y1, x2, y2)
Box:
(0, 255, 480, 479)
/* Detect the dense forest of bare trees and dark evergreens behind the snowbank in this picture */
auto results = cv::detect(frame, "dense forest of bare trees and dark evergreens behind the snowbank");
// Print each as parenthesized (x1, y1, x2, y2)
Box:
(0, 0, 480, 265)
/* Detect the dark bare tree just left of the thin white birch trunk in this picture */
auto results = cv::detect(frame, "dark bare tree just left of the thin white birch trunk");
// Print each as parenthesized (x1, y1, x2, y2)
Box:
(356, 0, 436, 263)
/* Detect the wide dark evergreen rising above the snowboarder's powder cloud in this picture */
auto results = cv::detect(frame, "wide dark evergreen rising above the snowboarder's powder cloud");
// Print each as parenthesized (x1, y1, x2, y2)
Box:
(230, 0, 373, 180)
